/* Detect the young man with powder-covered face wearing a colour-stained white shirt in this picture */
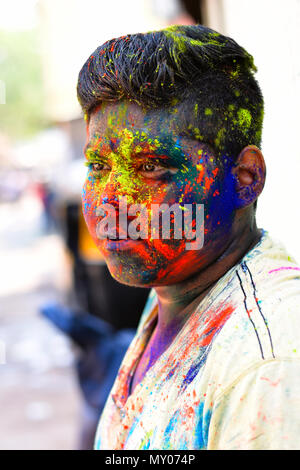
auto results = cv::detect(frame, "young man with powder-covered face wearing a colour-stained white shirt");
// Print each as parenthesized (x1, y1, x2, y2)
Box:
(78, 26, 300, 450)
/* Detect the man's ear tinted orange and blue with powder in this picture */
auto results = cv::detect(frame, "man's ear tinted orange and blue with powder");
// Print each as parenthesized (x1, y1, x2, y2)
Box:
(232, 145, 266, 208)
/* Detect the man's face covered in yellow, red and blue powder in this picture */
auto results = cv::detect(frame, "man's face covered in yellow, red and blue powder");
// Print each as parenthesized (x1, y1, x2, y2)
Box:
(83, 101, 235, 287)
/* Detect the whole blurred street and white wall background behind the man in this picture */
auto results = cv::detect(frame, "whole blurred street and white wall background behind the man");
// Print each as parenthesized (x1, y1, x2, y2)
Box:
(0, 0, 300, 450)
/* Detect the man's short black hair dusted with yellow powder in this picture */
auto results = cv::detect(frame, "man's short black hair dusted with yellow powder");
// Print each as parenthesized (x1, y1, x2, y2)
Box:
(77, 25, 264, 160)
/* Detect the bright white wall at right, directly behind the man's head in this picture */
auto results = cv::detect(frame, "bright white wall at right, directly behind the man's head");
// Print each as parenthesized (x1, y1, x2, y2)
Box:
(206, 0, 300, 262)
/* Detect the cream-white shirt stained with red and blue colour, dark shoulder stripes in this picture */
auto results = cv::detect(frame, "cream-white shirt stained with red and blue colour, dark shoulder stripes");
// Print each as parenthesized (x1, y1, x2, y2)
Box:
(95, 232, 300, 450)
